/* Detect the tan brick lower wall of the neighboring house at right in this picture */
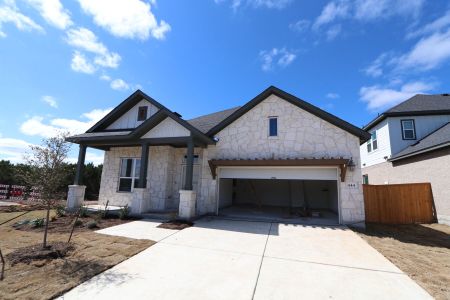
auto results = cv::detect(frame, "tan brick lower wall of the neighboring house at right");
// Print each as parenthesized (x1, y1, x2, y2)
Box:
(362, 148, 450, 225)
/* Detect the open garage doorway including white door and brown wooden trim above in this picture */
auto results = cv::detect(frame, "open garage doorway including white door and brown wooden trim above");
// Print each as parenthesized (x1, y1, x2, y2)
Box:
(210, 159, 346, 225)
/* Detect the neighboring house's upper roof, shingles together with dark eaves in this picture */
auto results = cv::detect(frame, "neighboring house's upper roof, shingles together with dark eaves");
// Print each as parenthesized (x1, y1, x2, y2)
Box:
(363, 94, 450, 130)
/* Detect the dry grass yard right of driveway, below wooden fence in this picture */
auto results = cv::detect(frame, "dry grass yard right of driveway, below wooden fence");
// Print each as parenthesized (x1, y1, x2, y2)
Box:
(358, 224, 450, 299)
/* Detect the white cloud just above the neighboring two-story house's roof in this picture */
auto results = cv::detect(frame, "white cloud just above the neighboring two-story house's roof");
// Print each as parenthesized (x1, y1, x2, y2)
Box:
(359, 81, 435, 111)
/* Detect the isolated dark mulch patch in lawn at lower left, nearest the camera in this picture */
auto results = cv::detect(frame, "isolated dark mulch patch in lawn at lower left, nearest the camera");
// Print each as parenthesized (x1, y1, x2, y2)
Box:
(6, 242, 75, 265)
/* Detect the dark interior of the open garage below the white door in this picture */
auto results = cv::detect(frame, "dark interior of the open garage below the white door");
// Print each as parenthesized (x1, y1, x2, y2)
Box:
(219, 178, 339, 225)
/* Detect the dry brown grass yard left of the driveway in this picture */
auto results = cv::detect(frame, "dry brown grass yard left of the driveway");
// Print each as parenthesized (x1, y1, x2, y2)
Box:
(0, 211, 154, 300)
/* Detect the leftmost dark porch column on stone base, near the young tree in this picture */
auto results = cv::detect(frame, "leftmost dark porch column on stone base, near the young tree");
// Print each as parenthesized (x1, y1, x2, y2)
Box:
(66, 145, 87, 210)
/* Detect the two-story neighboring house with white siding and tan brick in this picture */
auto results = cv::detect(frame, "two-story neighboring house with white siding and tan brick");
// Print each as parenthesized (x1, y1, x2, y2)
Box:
(361, 94, 450, 224)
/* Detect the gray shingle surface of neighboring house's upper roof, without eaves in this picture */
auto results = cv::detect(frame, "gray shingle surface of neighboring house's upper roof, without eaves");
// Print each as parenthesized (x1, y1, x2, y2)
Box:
(386, 94, 450, 113)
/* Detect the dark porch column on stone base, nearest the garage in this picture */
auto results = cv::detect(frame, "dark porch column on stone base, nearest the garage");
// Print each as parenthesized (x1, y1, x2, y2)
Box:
(178, 137, 197, 220)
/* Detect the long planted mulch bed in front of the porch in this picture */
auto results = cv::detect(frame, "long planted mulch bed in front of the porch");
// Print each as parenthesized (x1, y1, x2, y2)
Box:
(13, 213, 137, 233)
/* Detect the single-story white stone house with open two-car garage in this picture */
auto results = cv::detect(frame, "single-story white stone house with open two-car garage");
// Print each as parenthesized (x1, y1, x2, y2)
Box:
(67, 87, 369, 223)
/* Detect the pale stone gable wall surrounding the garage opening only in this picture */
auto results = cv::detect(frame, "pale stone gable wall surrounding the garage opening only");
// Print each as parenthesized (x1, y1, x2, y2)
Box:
(197, 95, 364, 223)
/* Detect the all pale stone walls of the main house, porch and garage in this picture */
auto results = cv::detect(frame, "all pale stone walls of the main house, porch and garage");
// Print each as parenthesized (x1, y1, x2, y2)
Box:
(96, 95, 364, 223)
